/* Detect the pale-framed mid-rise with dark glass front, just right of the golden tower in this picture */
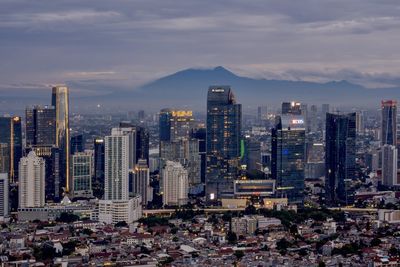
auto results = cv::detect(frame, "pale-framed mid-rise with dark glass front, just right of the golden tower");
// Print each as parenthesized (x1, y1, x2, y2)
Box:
(71, 150, 93, 198)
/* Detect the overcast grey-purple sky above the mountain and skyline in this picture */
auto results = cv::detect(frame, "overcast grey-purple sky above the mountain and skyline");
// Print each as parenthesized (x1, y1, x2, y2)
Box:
(0, 0, 400, 96)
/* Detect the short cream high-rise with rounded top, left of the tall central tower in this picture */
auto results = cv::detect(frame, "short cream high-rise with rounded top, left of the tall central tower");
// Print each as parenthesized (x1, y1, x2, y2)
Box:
(162, 161, 189, 206)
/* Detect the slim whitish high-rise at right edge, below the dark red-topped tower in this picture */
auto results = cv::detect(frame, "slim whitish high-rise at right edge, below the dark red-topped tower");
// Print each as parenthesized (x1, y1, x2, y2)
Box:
(382, 145, 398, 186)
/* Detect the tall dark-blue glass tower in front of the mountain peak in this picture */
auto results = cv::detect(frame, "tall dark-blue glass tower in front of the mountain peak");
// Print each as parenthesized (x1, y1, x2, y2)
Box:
(206, 86, 242, 200)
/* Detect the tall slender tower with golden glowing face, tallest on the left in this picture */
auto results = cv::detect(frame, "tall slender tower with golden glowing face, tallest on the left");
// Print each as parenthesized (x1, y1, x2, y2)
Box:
(51, 86, 71, 193)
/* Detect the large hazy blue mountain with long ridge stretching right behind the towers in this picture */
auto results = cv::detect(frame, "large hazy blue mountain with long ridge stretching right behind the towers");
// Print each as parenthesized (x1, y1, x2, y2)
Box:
(132, 67, 400, 108)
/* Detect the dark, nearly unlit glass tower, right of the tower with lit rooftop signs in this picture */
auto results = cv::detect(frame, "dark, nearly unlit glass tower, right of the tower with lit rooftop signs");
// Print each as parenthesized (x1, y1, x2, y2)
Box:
(325, 113, 356, 205)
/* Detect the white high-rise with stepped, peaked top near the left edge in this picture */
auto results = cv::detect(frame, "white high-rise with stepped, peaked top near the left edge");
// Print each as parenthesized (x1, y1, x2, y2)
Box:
(19, 151, 46, 208)
